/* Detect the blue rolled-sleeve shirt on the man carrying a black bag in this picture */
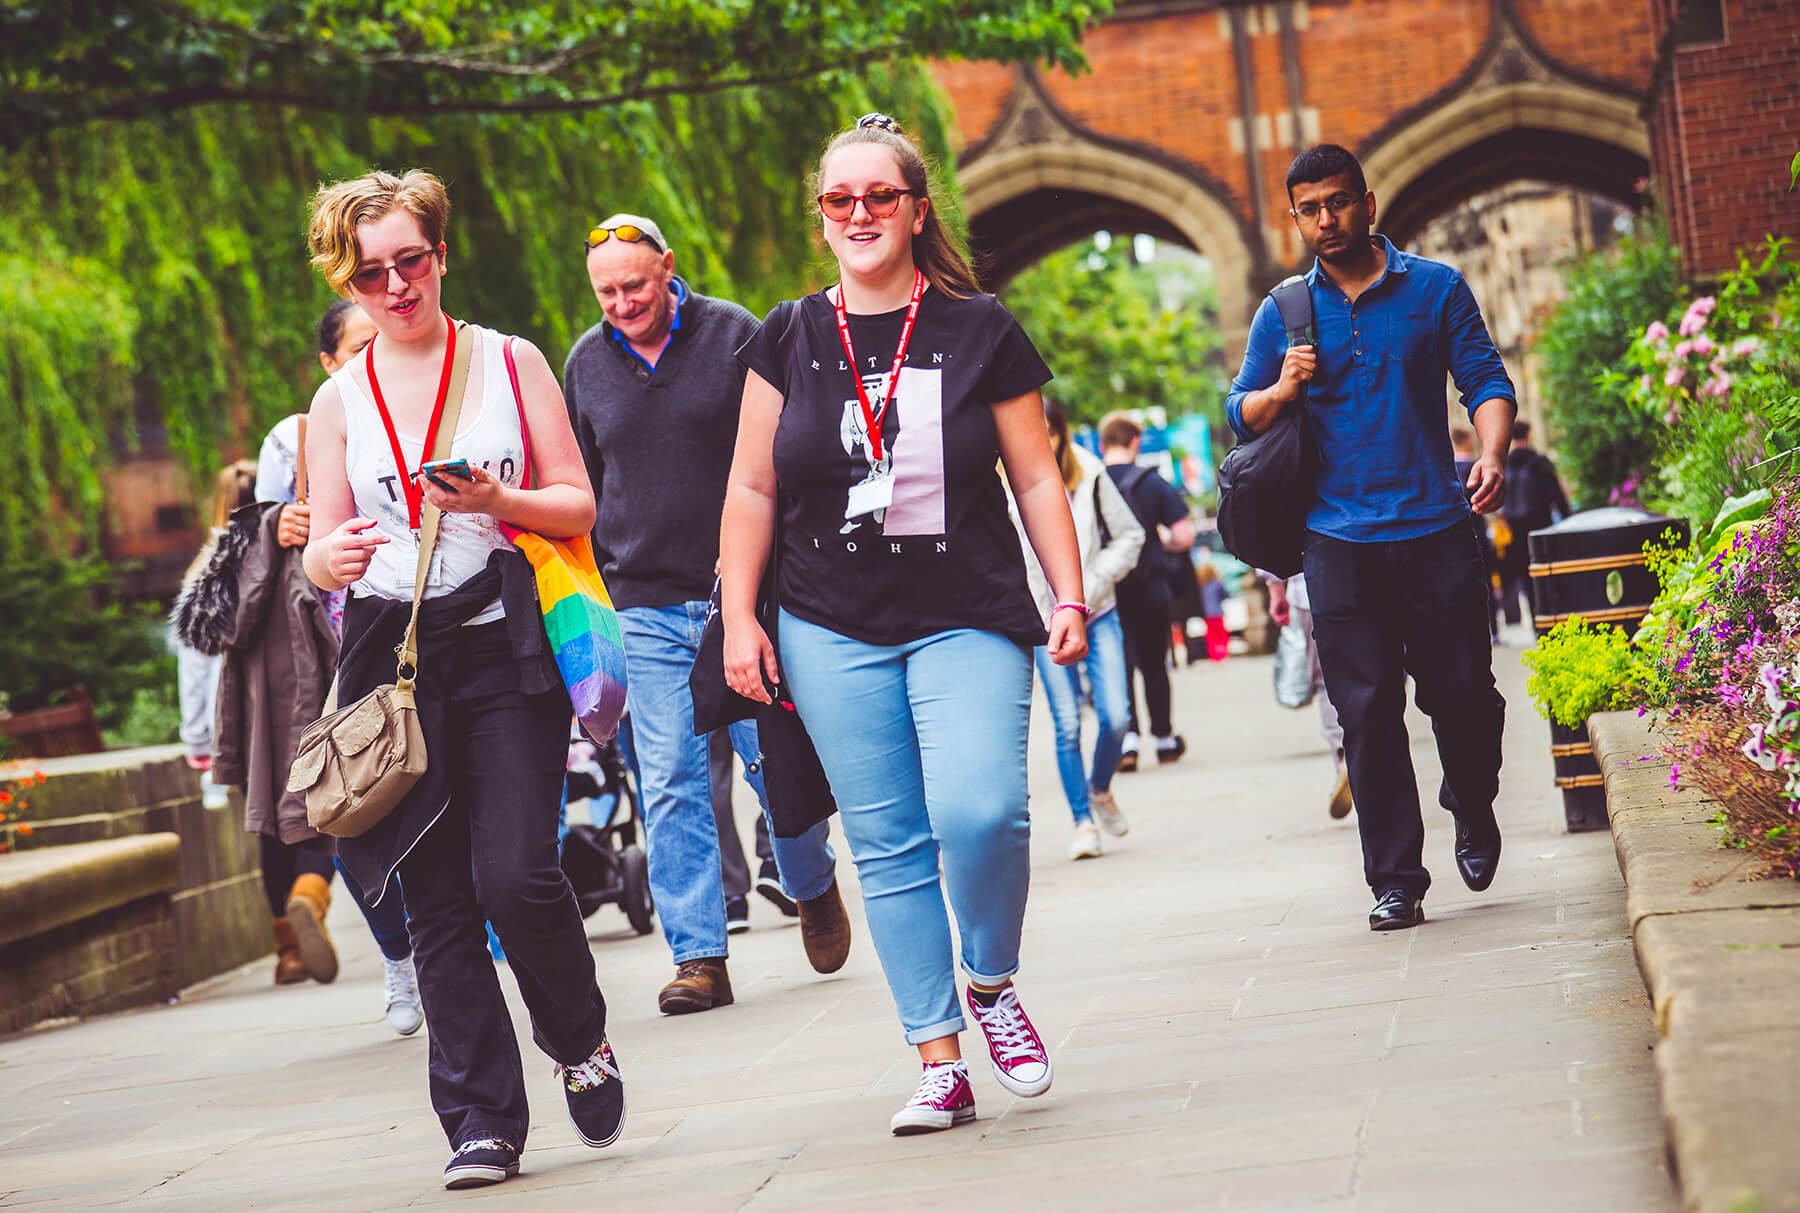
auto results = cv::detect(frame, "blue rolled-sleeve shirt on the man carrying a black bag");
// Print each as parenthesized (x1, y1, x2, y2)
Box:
(1226, 236, 1517, 544)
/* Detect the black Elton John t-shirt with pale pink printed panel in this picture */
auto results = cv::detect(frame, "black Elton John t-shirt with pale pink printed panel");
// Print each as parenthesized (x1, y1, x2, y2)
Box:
(738, 290, 1049, 644)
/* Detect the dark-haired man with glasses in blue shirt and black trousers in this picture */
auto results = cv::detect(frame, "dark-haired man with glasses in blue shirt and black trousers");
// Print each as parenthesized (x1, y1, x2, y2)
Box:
(1226, 144, 1517, 930)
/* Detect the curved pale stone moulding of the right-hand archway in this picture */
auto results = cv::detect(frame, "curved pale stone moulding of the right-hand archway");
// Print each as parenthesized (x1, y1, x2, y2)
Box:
(1359, 81, 1651, 245)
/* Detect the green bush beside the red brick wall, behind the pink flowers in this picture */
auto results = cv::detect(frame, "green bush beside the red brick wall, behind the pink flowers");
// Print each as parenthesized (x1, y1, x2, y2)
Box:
(1535, 220, 1681, 506)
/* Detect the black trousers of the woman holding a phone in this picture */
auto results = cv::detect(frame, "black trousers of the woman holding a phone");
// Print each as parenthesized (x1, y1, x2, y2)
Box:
(400, 623, 607, 1148)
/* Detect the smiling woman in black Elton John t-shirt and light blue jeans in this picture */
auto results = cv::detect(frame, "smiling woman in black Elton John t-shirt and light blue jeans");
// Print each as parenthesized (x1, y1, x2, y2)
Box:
(720, 113, 1087, 1134)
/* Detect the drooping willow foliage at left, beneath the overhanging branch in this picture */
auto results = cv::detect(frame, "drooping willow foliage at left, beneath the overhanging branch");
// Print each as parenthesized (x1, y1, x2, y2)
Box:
(0, 65, 959, 565)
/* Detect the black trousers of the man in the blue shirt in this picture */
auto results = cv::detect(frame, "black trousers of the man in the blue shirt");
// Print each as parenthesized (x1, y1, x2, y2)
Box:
(1305, 522, 1507, 896)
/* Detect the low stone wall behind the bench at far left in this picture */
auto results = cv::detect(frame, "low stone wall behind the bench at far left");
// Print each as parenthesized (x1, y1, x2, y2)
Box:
(0, 745, 274, 986)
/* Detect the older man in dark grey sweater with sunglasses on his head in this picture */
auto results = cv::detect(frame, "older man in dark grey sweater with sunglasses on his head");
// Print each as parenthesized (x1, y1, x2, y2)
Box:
(563, 214, 850, 1015)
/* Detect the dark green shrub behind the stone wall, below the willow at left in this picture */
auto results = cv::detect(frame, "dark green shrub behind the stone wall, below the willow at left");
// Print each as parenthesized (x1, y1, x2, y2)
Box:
(0, 553, 175, 740)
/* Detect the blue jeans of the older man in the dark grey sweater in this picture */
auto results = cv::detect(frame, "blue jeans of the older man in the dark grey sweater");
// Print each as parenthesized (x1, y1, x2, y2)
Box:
(619, 603, 837, 965)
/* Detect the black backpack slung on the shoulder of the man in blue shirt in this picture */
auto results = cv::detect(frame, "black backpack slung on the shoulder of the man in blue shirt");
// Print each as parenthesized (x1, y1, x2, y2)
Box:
(1219, 275, 1319, 578)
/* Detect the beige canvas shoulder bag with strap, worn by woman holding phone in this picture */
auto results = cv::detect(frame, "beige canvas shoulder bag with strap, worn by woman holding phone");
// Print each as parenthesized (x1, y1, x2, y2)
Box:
(288, 326, 475, 839)
